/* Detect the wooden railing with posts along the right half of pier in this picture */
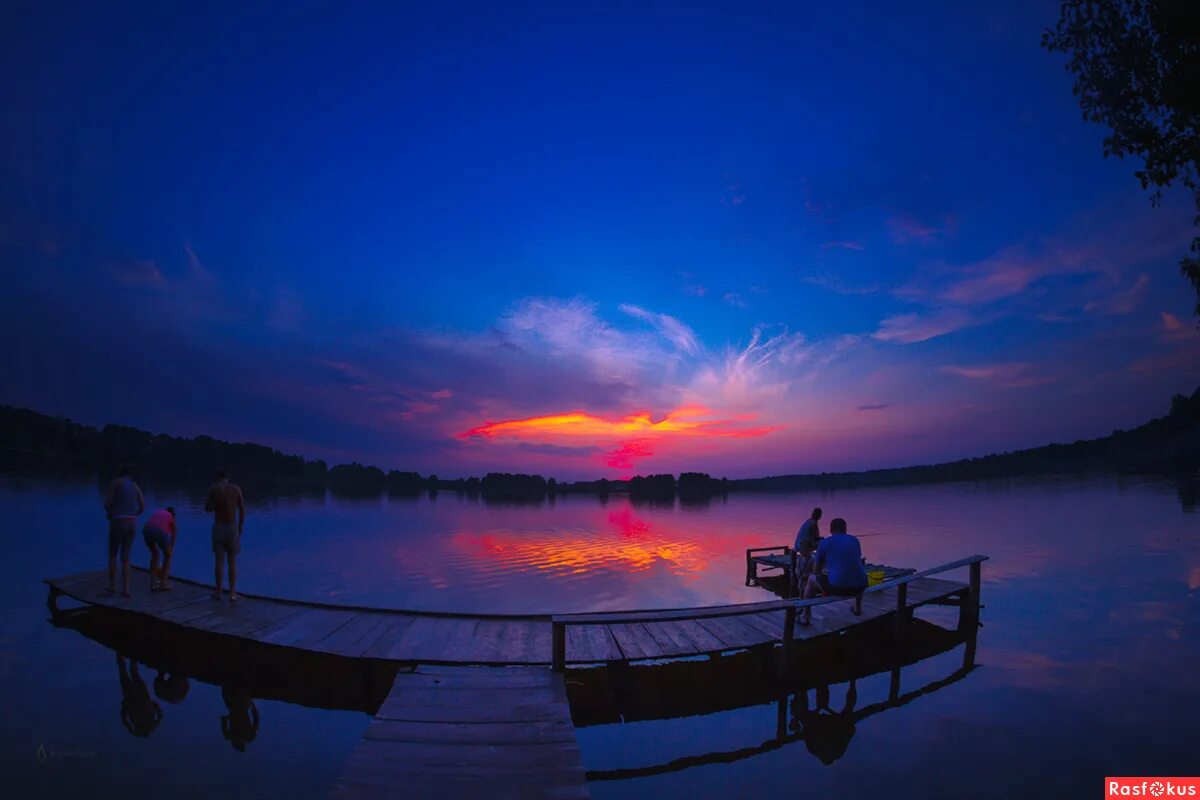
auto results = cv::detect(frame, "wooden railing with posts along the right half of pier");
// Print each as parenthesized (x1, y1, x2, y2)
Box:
(551, 555, 988, 672)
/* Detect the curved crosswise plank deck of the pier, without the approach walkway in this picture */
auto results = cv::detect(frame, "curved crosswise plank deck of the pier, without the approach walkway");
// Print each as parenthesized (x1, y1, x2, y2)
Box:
(47, 571, 967, 666)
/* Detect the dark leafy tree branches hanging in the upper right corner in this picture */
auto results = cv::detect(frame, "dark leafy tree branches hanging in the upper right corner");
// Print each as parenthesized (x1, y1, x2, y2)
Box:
(1042, 0, 1200, 315)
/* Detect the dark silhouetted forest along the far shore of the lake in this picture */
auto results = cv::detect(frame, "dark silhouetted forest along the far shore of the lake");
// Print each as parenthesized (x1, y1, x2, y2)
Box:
(0, 389, 1200, 500)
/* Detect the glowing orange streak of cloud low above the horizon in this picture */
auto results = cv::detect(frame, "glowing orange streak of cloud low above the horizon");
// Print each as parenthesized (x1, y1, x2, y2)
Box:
(458, 405, 779, 439)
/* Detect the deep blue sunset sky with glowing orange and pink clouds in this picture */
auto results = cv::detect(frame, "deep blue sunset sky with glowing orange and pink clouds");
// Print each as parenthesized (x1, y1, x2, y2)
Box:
(0, 2, 1200, 479)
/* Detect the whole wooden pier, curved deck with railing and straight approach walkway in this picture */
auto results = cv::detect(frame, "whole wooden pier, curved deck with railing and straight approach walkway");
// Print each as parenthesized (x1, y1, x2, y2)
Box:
(47, 555, 986, 798)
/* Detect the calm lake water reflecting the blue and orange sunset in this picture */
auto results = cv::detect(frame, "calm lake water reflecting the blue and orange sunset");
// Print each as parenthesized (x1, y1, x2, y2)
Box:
(0, 475, 1200, 798)
